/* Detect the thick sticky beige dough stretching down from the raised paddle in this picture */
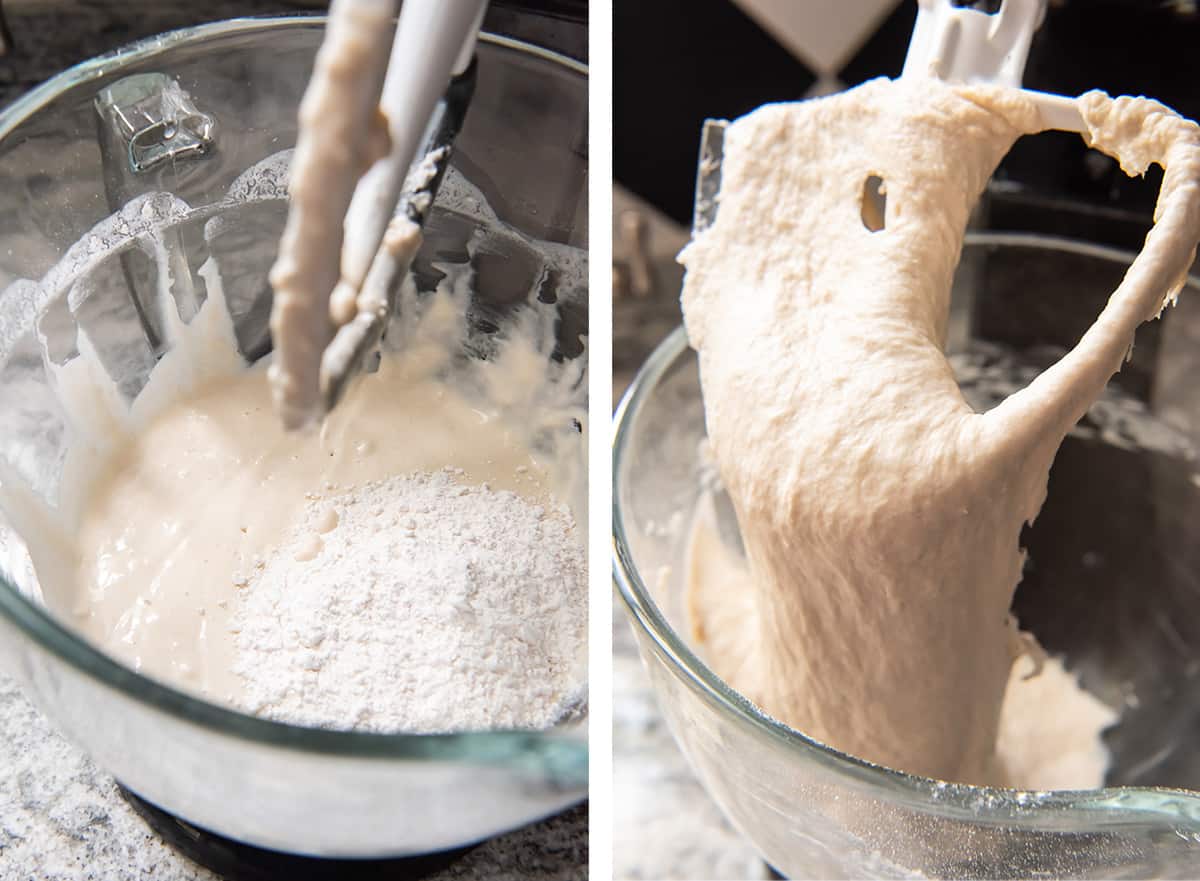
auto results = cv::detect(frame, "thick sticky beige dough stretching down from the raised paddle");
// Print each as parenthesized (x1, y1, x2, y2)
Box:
(680, 79, 1200, 784)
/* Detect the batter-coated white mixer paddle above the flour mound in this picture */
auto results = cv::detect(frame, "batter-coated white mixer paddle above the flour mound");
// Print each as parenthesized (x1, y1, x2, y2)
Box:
(271, 0, 487, 428)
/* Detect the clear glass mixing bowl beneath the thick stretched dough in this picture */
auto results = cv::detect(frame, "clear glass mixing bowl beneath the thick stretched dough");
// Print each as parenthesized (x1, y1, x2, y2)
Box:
(613, 233, 1200, 879)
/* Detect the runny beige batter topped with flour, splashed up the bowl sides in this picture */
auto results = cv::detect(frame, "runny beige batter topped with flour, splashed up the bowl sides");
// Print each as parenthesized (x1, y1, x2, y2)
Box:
(0, 170, 587, 733)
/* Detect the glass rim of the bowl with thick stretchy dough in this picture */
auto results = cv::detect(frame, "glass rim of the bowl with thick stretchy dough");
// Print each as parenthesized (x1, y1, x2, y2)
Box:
(612, 232, 1200, 831)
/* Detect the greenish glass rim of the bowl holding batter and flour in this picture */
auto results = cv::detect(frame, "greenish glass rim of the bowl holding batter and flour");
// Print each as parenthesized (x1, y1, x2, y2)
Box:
(0, 14, 588, 772)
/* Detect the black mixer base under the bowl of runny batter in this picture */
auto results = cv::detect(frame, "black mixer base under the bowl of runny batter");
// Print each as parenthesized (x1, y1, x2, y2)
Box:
(118, 785, 474, 881)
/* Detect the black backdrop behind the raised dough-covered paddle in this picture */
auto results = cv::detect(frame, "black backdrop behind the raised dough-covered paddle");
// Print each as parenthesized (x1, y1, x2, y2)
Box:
(613, 0, 1200, 241)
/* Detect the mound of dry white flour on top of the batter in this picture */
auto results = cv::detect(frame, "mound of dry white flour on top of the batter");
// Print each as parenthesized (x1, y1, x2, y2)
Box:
(233, 469, 587, 733)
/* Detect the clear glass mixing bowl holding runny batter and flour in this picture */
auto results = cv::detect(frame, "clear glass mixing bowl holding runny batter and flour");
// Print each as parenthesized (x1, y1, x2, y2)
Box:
(0, 18, 587, 857)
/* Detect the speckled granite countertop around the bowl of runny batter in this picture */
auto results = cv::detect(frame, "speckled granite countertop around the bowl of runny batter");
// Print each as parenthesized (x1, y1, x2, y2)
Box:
(0, 6, 588, 881)
